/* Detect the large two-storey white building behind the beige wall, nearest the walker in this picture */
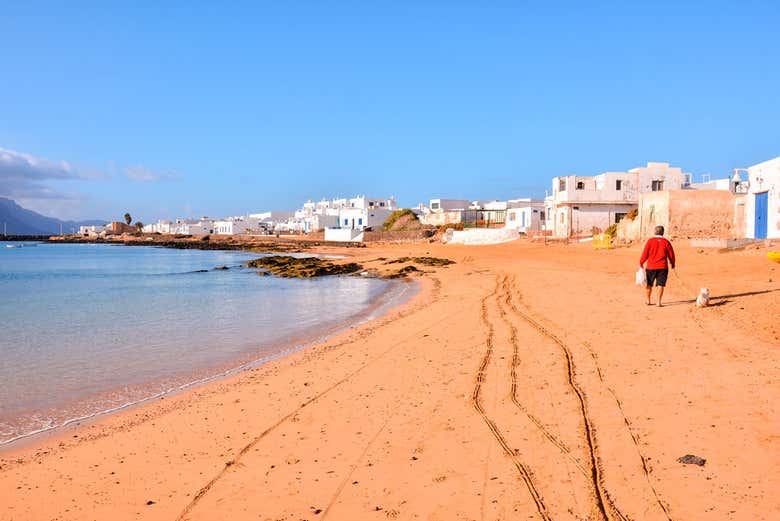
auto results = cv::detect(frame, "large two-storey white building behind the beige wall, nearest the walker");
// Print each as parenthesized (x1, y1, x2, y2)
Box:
(545, 163, 690, 237)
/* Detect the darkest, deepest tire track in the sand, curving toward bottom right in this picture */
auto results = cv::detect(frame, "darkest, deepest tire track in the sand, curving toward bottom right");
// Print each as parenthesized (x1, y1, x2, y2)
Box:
(505, 276, 629, 521)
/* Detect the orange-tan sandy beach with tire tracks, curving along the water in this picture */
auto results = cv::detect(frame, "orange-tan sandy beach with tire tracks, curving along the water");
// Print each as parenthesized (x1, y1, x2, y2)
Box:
(0, 240, 780, 521)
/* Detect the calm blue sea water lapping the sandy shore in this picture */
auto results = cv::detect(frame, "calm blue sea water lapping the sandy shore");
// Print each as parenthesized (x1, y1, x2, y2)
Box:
(0, 242, 409, 444)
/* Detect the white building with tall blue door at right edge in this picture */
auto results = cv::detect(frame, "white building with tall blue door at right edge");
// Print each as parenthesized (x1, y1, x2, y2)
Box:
(745, 157, 780, 239)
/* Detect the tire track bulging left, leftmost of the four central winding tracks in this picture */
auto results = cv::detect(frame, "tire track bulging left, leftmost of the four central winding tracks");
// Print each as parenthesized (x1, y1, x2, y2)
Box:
(471, 278, 552, 521)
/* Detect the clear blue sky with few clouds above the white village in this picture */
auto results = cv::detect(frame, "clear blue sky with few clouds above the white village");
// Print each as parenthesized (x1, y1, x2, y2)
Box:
(0, 0, 780, 222)
